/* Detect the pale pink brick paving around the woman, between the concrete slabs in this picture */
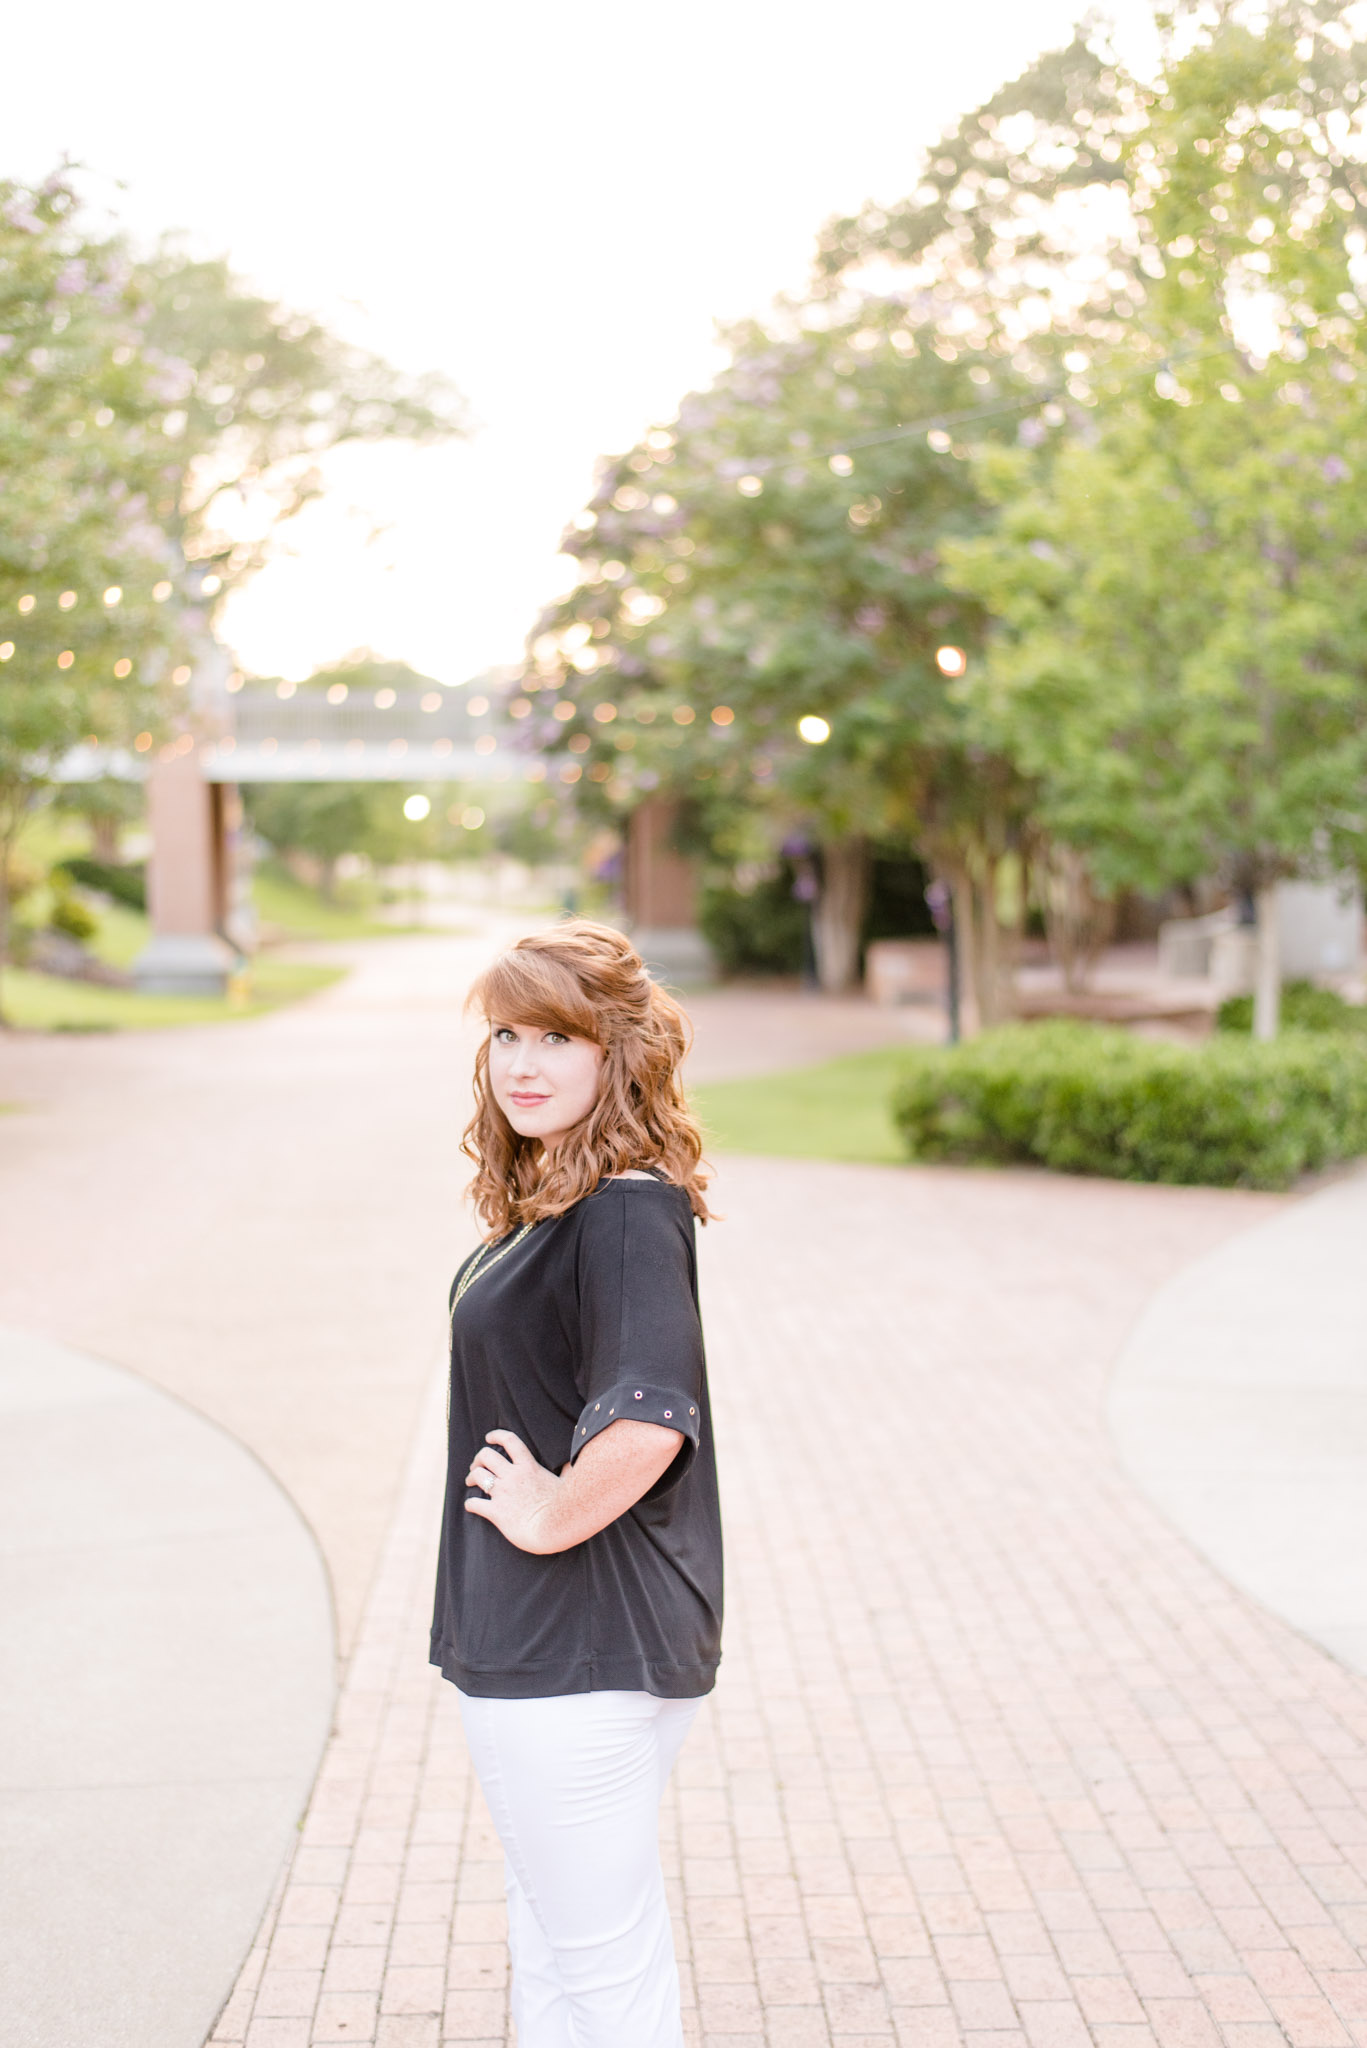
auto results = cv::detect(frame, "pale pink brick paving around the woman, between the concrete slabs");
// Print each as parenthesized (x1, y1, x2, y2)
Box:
(213, 1161, 1367, 2048)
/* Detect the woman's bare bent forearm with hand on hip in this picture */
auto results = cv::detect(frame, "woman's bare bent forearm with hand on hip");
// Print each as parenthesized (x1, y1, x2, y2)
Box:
(465, 1417, 682, 1556)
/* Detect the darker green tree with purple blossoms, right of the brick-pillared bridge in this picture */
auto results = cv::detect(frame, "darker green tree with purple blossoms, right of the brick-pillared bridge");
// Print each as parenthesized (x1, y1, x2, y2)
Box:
(523, 303, 1032, 987)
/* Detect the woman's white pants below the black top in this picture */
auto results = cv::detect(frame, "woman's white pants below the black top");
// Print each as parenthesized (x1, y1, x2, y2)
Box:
(459, 1692, 701, 2048)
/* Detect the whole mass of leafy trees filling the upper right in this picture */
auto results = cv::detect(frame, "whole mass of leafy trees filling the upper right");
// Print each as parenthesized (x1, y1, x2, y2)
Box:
(519, 0, 1367, 1022)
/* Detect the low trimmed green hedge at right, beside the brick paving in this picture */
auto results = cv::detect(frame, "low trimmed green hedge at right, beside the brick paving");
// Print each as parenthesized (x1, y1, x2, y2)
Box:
(892, 1024, 1367, 1188)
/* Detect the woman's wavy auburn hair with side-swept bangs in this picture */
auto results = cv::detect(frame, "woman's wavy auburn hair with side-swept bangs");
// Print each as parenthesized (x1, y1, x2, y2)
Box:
(461, 918, 711, 1237)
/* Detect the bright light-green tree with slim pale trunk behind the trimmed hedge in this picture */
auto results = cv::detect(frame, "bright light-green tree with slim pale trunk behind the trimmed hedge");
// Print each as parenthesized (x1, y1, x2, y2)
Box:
(949, 6, 1367, 1036)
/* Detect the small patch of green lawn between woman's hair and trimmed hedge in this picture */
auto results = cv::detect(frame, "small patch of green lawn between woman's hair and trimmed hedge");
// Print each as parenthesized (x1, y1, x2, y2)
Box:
(689, 1047, 906, 1165)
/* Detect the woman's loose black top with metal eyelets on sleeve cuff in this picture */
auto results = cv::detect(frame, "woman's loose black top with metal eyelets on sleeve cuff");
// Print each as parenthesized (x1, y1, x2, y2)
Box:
(432, 1180, 721, 1700)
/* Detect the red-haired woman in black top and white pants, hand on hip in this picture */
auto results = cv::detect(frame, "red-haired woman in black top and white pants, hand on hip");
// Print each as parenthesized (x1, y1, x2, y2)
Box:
(432, 922, 721, 2048)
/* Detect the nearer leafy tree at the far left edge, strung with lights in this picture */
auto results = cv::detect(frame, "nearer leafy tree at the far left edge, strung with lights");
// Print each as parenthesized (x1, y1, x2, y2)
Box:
(0, 176, 178, 1007)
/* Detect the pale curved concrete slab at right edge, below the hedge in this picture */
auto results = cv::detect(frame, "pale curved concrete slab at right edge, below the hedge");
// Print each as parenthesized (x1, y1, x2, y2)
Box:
(1109, 1171, 1367, 1673)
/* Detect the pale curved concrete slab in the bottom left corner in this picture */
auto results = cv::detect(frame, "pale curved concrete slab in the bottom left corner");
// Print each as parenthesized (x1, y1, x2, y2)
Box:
(0, 1329, 336, 2048)
